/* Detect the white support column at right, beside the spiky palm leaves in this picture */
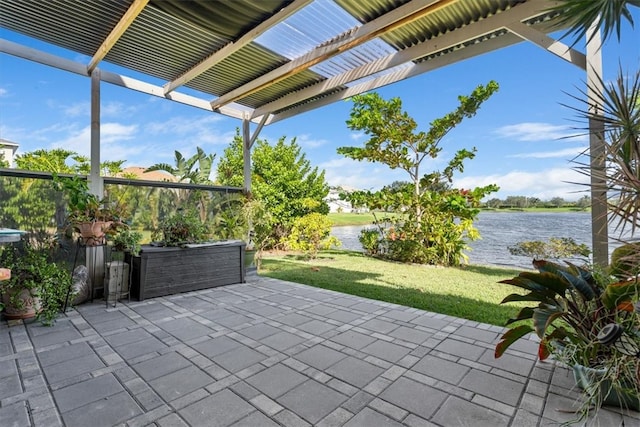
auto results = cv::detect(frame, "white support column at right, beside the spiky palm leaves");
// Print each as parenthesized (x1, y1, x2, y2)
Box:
(587, 25, 609, 266)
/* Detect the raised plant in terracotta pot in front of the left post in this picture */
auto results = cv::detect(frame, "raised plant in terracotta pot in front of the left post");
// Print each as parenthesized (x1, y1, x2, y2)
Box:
(53, 173, 125, 246)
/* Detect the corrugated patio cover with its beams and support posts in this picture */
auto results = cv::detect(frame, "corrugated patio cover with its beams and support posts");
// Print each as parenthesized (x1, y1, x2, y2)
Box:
(0, 0, 608, 259)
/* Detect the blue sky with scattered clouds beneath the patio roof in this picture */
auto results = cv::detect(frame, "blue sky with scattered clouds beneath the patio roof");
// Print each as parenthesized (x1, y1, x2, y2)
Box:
(0, 8, 640, 200)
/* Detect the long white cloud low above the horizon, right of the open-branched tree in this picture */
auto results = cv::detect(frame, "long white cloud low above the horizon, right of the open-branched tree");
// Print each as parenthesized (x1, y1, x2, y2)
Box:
(454, 167, 589, 200)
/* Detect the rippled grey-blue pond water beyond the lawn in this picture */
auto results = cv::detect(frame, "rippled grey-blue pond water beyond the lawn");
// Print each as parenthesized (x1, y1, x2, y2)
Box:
(331, 212, 591, 267)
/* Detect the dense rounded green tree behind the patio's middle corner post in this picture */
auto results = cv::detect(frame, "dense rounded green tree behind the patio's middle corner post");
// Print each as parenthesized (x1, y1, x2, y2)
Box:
(217, 131, 329, 246)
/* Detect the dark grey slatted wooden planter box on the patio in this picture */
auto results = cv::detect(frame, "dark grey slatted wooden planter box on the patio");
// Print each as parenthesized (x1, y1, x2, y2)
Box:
(131, 240, 245, 301)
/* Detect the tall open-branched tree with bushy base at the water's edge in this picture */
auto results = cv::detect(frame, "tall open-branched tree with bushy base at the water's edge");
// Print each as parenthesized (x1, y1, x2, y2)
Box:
(338, 81, 498, 265)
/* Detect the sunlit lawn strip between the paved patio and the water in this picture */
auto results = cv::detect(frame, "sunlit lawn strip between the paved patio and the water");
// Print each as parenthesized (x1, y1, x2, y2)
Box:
(260, 251, 522, 326)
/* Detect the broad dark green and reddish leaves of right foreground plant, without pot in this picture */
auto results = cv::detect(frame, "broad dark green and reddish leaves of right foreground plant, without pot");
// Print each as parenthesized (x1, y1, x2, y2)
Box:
(495, 260, 640, 366)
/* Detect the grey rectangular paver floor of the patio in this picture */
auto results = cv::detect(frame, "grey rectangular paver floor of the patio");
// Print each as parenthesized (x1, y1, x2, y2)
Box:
(0, 276, 640, 427)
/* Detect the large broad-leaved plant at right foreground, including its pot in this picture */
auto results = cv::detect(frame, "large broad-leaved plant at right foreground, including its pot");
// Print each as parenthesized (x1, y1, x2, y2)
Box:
(495, 260, 640, 419)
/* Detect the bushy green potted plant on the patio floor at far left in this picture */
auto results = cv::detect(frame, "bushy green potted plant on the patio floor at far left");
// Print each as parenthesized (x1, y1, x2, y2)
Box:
(0, 244, 71, 325)
